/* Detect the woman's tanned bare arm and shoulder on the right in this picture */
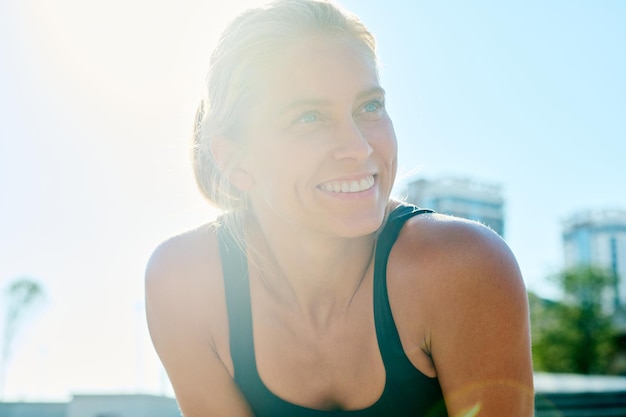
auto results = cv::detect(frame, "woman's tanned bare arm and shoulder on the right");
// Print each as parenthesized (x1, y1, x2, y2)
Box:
(388, 214, 533, 416)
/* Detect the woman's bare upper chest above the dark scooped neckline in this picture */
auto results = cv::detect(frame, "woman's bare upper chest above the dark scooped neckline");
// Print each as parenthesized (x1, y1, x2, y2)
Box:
(252, 276, 385, 409)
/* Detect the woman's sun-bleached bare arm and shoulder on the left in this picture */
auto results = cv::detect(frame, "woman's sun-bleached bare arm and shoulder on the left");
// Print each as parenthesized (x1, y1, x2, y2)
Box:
(146, 231, 252, 417)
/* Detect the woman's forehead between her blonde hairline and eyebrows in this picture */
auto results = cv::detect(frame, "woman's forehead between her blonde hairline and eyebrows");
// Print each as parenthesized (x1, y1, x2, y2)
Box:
(252, 36, 379, 106)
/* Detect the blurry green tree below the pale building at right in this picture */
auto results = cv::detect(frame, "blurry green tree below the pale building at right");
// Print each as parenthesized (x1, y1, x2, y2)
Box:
(529, 267, 617, 374)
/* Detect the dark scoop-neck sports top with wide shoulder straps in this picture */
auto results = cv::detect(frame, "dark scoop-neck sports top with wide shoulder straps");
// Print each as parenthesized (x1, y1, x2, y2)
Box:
(218, 205, 447, 417)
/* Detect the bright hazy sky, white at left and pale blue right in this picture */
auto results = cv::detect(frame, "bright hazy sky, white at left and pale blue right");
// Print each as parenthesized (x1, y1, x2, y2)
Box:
(0, 0, 626, 400)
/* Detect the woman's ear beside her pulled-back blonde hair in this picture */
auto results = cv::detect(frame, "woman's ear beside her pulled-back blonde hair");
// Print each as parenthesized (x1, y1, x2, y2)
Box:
(209, 137, 254, 192)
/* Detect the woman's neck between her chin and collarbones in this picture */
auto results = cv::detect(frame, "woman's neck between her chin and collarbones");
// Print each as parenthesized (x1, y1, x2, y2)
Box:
(246, 213, 375, 322)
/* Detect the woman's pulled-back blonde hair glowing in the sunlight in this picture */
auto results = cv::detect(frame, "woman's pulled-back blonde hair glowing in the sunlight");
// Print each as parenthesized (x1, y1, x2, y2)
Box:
(192, 0, 376, 236)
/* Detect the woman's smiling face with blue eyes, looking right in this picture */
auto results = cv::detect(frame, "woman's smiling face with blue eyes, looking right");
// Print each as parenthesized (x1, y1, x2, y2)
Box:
(240, 36, 397, 237)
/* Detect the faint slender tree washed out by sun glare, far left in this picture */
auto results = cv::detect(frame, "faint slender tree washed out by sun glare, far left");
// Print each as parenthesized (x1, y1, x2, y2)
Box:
(0, 277, 44, 396)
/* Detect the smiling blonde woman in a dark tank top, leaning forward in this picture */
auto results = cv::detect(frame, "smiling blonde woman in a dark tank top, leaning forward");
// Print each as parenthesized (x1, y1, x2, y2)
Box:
(146, 0, 533, 417)
